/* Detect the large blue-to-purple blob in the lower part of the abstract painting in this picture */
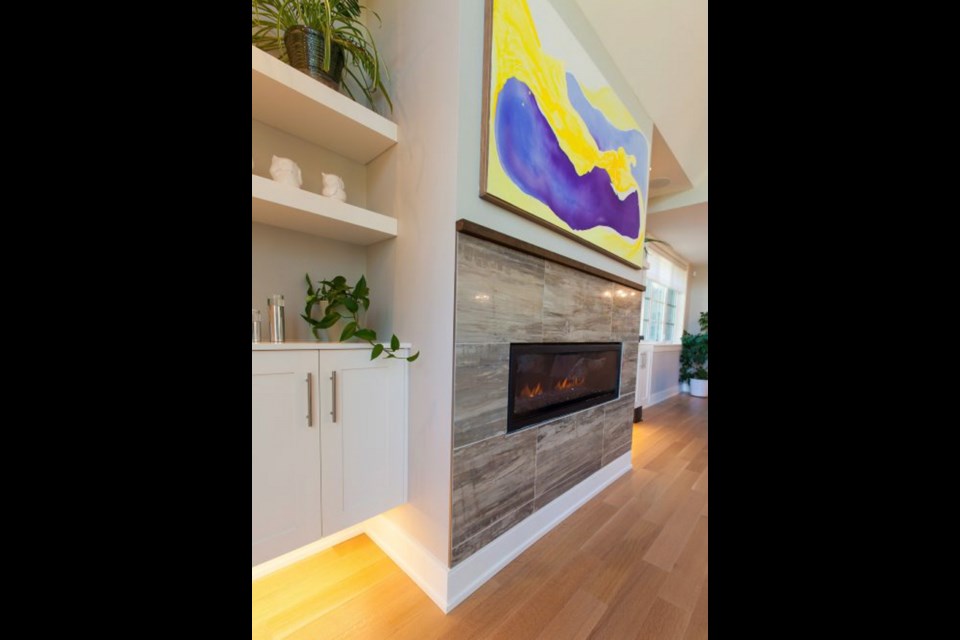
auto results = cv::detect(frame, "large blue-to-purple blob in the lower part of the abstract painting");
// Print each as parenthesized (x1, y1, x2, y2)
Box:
(494, 78, 640, 238)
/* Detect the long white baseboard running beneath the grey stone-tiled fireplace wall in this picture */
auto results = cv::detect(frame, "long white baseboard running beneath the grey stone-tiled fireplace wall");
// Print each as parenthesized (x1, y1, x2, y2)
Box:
(441, 451, 632, 612)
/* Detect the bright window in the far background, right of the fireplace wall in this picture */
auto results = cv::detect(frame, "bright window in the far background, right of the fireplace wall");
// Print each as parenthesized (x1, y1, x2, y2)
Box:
(641, 245, 687, 343)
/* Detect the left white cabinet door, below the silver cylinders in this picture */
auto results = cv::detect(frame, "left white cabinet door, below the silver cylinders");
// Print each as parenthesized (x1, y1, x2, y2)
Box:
(252, 351, 322, 565)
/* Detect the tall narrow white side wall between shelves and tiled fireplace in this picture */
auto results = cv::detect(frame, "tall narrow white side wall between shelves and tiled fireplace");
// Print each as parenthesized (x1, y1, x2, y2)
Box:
(367, 0, 459, 567)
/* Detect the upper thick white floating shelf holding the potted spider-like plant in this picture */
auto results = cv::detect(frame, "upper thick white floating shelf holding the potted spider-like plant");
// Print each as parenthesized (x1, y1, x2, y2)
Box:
(253, 47, 397, 164)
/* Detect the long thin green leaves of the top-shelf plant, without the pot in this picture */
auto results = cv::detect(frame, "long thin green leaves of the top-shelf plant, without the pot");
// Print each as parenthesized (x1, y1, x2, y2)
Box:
(252, 0, 393, 112)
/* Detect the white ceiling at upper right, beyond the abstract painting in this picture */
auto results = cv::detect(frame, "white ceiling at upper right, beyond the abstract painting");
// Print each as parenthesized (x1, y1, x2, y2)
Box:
(574, 0, 707, 265)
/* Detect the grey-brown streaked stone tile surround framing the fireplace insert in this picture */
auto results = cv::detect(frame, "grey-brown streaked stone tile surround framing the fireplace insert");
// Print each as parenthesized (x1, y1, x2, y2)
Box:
(450, 233, 642, 566)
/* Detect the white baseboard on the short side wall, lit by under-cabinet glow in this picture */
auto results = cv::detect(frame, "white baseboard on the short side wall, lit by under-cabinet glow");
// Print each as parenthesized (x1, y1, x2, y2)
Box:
(363, 515, 450, 613)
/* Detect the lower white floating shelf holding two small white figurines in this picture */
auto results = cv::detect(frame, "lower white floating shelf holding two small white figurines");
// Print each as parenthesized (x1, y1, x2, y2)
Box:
(252, 175, 397, 246)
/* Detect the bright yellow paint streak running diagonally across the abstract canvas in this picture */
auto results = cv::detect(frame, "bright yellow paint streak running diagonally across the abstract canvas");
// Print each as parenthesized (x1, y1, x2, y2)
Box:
(489, 0, 639, 194)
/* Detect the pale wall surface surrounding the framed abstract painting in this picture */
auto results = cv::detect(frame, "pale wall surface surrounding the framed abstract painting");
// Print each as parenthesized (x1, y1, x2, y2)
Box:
(457, 0, 653, 284)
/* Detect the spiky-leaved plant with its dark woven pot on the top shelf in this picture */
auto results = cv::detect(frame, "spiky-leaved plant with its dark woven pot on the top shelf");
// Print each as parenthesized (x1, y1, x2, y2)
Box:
(252, 0, 393, 111)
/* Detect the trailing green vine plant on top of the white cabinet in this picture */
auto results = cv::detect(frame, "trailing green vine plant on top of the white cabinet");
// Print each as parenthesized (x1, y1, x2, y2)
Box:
(300, 273, 420, 362)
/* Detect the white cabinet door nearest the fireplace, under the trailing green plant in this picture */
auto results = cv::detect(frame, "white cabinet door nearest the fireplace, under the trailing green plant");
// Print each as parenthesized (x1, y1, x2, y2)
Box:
(320, 349, 407, 536)
